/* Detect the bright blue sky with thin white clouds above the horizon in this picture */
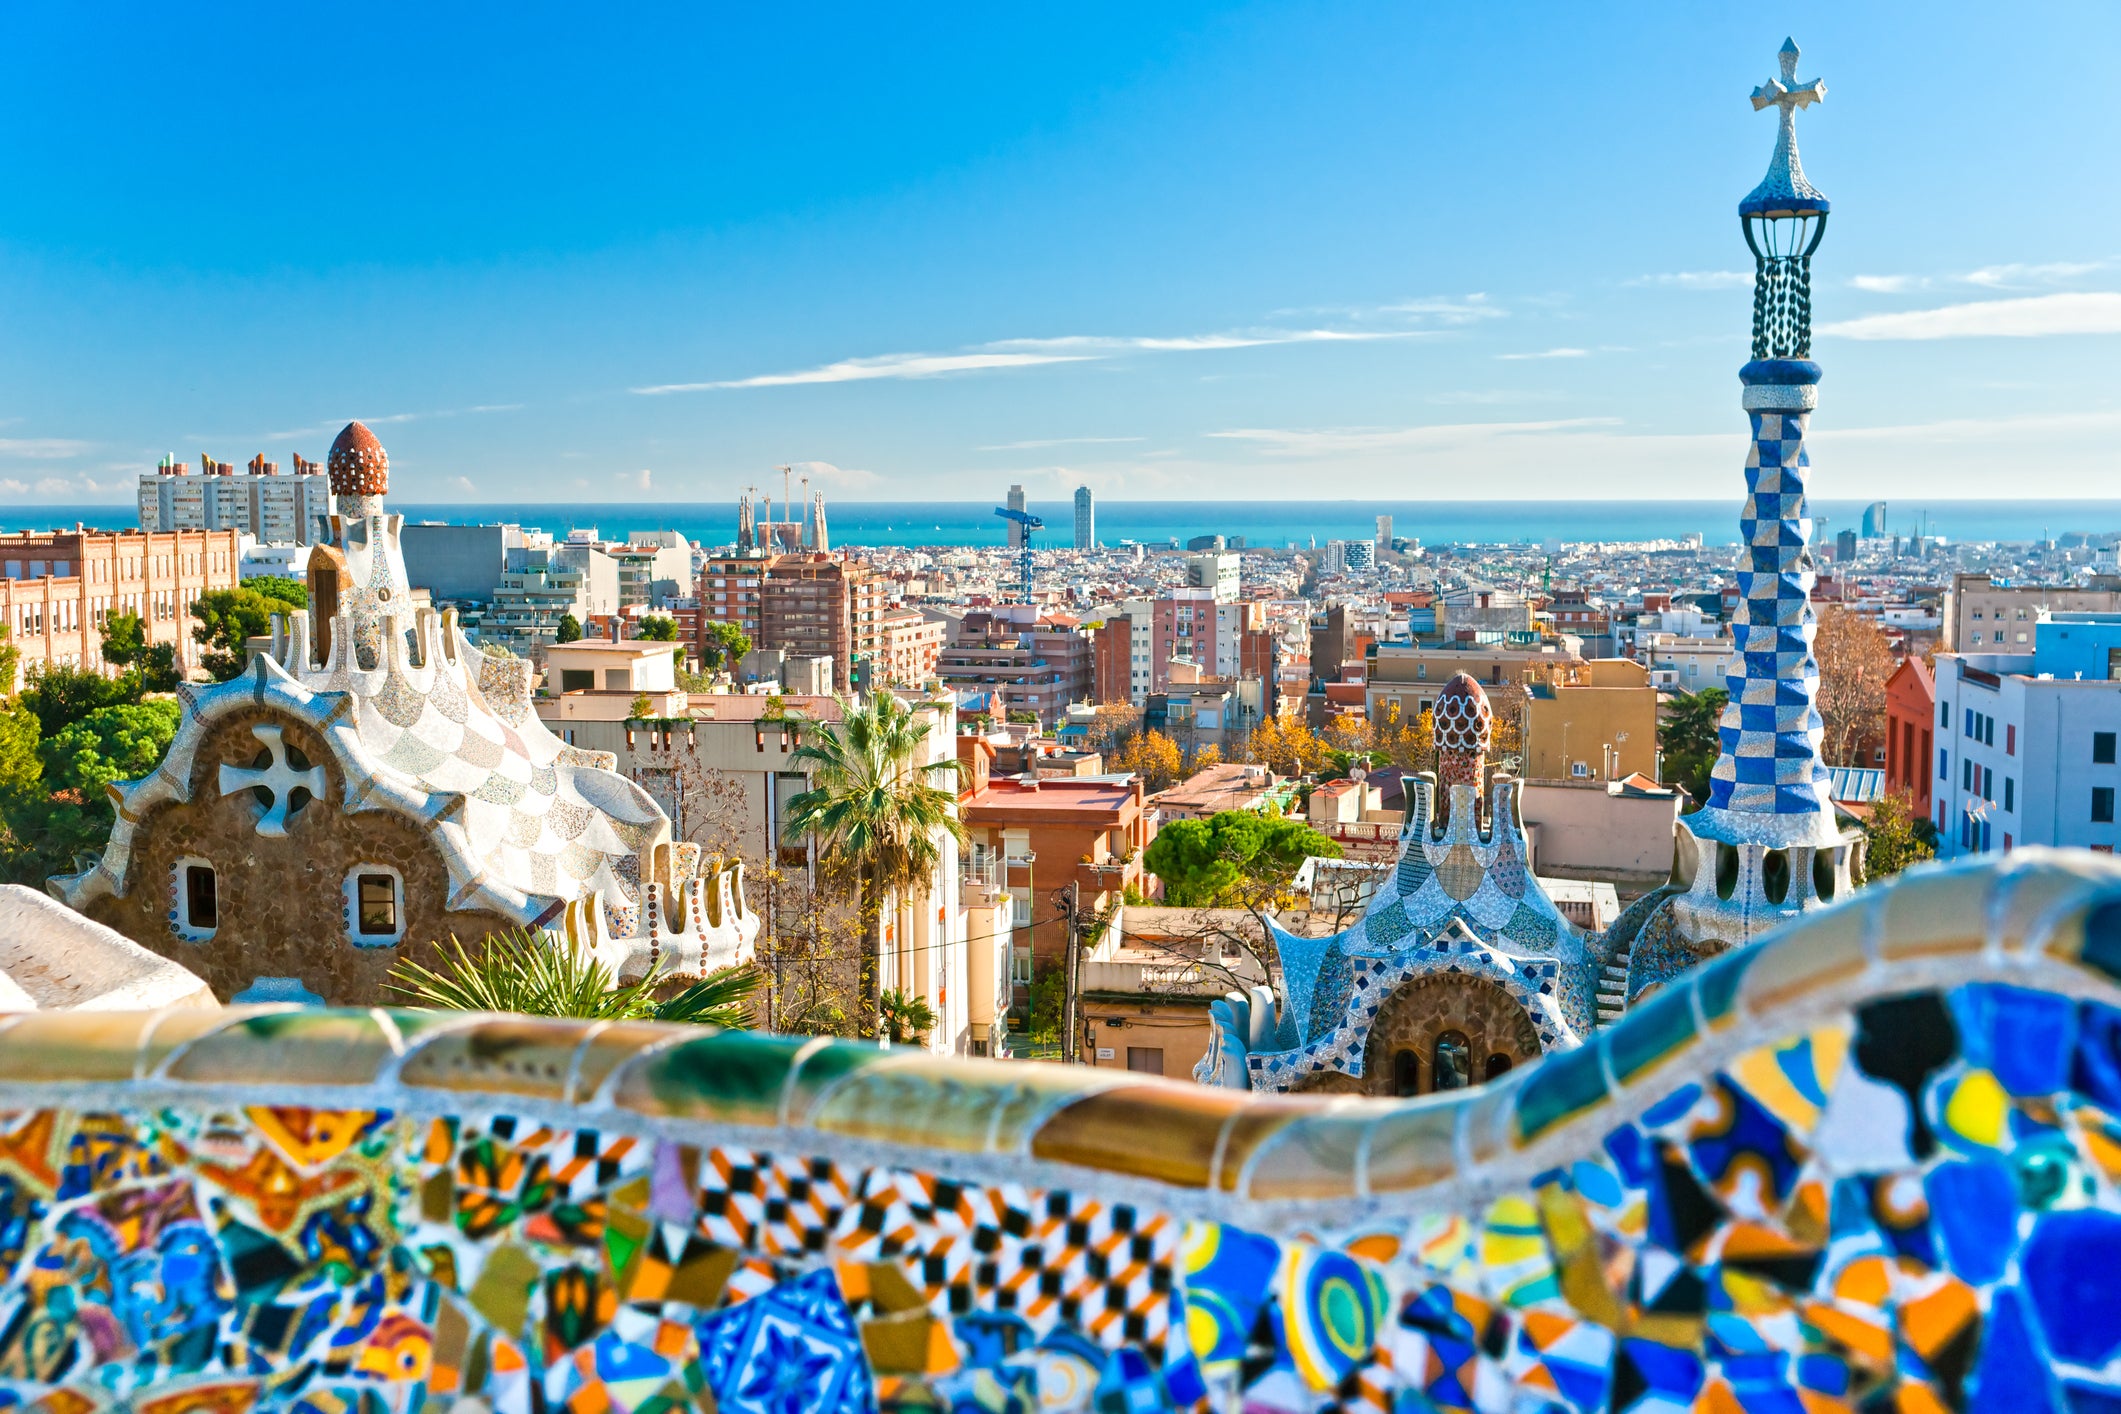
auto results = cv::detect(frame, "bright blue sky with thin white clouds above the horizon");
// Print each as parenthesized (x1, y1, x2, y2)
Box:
(0, 0, 2121, 502)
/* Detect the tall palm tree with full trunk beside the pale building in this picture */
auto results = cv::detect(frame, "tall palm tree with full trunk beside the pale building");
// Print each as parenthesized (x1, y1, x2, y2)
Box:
(783, 693, 965, 1026)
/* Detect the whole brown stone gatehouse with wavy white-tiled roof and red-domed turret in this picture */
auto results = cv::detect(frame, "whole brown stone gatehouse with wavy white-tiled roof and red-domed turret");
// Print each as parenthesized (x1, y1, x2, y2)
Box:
(51, 422, 759, 1005)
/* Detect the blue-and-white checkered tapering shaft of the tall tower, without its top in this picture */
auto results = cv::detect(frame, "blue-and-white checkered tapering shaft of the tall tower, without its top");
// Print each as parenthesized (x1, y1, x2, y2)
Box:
(1710, 398, 1833, 816)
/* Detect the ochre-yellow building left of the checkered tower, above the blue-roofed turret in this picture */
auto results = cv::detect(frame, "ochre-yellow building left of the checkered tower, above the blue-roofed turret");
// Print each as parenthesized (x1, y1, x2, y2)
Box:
(1523, 657, 1657, 780)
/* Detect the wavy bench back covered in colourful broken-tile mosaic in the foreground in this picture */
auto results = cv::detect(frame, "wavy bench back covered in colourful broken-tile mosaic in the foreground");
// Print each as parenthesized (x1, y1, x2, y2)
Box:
(0, 852, 2121, 1414)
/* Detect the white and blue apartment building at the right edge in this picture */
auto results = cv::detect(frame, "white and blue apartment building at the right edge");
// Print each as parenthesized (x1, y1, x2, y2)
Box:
(1930, 613, 2121, 859)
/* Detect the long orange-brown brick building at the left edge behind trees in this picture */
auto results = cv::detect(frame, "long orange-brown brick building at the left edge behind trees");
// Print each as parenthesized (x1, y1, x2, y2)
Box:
(0, 530, 242, 691)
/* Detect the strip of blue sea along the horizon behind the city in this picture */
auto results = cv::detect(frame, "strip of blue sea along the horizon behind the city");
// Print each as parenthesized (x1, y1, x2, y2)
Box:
(0, 498, 2121, 549)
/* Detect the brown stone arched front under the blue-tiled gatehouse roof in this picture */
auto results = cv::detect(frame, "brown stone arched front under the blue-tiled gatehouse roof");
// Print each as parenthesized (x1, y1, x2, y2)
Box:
(1362, 973, 1546, 1096)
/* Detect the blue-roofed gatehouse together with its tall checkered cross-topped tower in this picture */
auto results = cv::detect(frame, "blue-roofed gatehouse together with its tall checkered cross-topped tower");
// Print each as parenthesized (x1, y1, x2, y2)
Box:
(1196, 42, 1862, 1094)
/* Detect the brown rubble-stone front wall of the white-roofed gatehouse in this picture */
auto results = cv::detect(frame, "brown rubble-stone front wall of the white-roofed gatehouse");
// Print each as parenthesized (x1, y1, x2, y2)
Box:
(87, 708, 513, 1005)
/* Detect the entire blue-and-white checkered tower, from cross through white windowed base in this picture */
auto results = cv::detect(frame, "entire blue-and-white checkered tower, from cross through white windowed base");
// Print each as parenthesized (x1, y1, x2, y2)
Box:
(1673, 42, 1862, 945)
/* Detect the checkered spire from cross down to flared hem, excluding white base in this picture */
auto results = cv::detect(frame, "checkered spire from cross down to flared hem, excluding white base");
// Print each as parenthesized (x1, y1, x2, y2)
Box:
(1695, 42, 1841, 846)
